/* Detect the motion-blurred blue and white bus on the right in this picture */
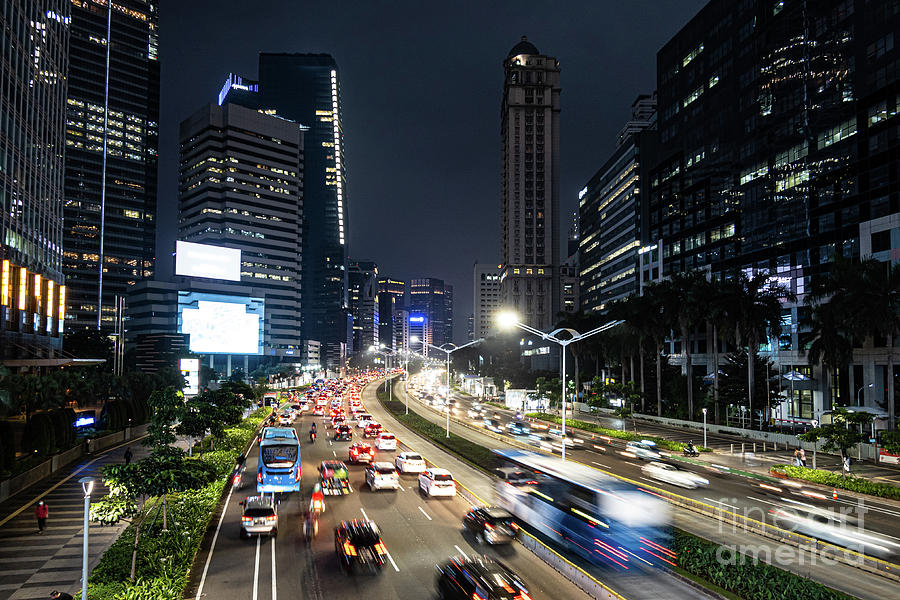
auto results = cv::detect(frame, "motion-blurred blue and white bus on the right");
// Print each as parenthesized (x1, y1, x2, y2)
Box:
(494, 449, 675, 571)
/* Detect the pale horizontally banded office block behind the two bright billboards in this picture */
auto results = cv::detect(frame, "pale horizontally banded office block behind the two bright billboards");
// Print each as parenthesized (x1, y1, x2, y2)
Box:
(178, 103, 304, 356)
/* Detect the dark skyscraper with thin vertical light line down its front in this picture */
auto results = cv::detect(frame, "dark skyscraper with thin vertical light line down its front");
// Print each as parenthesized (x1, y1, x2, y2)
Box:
(63, 0, 159, 329)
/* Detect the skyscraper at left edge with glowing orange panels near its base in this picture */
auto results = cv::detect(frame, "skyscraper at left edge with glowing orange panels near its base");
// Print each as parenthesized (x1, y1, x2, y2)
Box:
(0, 0, 71, 359)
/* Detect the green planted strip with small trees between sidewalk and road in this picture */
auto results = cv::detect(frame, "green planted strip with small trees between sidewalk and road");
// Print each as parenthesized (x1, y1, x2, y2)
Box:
(78, 388, 268, 600)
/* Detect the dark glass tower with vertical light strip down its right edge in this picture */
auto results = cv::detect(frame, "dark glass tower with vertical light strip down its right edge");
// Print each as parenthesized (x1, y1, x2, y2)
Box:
(259, 52, 349, 368)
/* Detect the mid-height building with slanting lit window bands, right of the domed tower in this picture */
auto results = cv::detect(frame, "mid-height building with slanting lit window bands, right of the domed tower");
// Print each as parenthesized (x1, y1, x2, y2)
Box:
(578, 94, 656, 312)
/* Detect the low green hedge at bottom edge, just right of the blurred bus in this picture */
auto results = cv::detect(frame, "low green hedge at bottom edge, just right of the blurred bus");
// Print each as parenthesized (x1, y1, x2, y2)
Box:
(672, 529, 853, 600)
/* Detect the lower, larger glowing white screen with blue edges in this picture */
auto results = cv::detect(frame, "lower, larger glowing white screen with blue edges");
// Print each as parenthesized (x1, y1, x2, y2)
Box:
(178, 291, 265, 354)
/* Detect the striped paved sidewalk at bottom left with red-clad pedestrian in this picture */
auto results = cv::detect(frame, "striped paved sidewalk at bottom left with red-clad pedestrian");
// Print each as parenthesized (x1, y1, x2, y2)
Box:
(0, 440, 149, 600)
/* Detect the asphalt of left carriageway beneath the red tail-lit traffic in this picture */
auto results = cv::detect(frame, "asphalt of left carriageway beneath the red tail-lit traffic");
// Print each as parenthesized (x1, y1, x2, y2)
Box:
(191, 386, 588, 600)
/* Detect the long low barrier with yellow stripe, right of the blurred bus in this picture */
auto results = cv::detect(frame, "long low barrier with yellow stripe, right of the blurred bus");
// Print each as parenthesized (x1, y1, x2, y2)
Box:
(413, 396, 900, 581)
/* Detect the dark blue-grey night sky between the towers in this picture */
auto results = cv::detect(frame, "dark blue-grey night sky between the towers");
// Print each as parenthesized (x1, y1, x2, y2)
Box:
(157, 0, 705, 341)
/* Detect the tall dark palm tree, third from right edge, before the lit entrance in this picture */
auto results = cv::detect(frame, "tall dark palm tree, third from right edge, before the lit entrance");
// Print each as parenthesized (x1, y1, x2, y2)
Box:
(728, 272, 795, 428)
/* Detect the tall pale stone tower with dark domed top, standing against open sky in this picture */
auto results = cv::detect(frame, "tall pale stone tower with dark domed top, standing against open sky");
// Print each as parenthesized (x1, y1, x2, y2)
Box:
(500, 36, 560, 329)
